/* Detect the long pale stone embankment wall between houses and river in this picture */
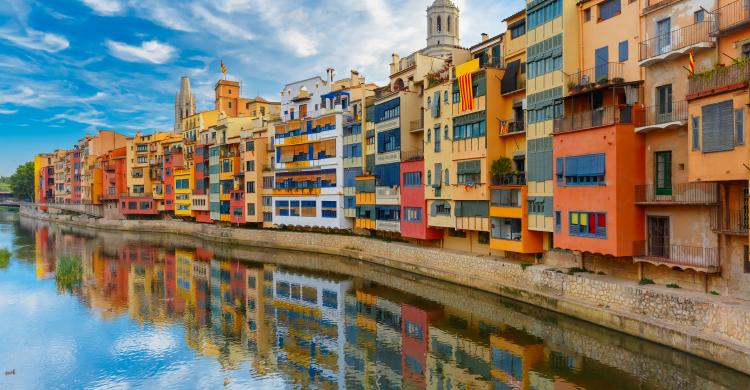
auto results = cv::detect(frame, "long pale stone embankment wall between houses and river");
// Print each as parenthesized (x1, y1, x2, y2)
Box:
(16, 208, 750, 373)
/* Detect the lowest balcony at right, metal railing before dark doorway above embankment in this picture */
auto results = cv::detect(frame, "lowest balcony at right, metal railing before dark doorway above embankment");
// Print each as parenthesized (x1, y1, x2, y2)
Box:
(633, 241, 721, 273)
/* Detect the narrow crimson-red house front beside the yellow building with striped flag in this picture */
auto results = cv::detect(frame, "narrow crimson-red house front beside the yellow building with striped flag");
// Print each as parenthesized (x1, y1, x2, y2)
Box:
(401, 158, 443, 240)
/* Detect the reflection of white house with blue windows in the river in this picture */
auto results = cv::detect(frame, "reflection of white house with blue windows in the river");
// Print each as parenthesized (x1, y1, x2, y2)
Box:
(273, 271, 351, 388)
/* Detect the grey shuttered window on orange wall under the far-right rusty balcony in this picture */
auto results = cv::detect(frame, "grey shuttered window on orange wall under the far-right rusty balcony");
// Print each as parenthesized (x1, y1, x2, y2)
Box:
(701, 100, 735, 153)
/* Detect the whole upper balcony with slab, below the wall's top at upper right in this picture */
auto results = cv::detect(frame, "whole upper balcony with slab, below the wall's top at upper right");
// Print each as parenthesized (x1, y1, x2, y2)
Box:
(639, 21, 715, 66)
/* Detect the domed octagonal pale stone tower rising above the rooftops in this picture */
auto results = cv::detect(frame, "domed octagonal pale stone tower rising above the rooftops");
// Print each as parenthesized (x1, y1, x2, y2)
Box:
(424, 0, 459, 57)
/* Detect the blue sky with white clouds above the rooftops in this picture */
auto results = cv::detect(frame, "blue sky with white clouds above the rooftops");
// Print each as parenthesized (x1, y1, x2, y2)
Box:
(0, 0, 524, 176)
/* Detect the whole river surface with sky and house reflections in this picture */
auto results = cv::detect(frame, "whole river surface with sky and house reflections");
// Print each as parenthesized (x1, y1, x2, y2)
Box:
(0, 213, 750, 390)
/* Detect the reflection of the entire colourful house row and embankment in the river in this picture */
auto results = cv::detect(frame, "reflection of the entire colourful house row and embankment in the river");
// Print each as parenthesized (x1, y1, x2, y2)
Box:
(5, 216, 750, 389)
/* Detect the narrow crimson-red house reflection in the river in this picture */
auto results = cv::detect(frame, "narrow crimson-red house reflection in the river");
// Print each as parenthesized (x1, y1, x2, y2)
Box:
(401, 304, 442, 387)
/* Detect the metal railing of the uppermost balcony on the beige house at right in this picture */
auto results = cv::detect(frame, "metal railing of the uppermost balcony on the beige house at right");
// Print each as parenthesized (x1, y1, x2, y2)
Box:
(640, 21, 712, 61)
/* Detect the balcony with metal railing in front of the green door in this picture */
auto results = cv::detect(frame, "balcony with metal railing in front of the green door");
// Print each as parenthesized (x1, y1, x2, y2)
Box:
(635, 182, 719, 206)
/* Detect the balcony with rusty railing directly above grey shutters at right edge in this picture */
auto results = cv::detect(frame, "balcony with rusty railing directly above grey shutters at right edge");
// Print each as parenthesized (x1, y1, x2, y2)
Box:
(686, 58, 750, 100)
